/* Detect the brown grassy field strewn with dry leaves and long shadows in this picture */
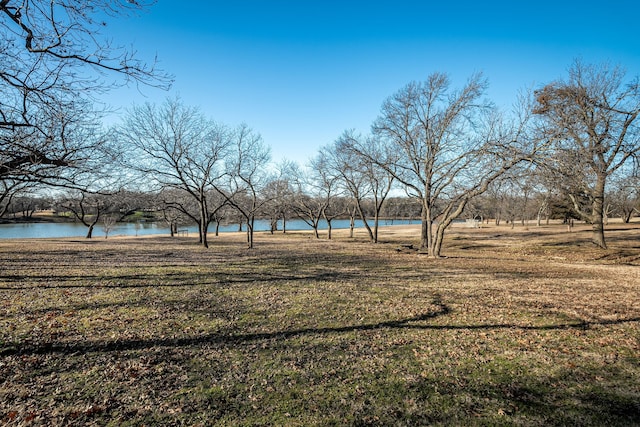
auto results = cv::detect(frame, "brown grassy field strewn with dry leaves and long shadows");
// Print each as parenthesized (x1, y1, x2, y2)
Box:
(0, 224, 640, 426)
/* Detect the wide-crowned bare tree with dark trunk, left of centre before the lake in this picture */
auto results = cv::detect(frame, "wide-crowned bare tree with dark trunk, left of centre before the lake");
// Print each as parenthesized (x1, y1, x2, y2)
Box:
(115, 99, 232, 247)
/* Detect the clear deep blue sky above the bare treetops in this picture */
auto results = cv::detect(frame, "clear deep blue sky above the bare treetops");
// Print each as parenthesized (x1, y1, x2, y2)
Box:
(100, 0, 640, 164)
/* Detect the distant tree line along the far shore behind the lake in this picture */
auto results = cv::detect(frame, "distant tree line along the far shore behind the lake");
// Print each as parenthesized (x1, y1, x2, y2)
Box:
(0, 174, 640, 241)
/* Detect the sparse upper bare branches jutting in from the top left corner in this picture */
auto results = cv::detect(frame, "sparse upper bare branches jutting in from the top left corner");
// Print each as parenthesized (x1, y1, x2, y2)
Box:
(0, 0, 170, 130)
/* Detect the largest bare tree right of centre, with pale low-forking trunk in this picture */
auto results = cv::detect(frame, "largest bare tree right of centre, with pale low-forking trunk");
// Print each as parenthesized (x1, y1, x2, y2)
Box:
(359, 73, 530, 257)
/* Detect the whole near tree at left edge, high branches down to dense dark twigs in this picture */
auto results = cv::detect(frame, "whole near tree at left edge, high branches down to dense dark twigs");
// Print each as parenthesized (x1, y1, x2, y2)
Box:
(0, 0, 170, 184)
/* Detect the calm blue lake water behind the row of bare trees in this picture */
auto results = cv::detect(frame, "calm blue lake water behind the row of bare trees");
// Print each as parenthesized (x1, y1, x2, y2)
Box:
(0, 219, 420, 239)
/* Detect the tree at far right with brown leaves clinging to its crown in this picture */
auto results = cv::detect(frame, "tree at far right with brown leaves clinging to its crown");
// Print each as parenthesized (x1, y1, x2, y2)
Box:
(535, 61, 640, 248)
